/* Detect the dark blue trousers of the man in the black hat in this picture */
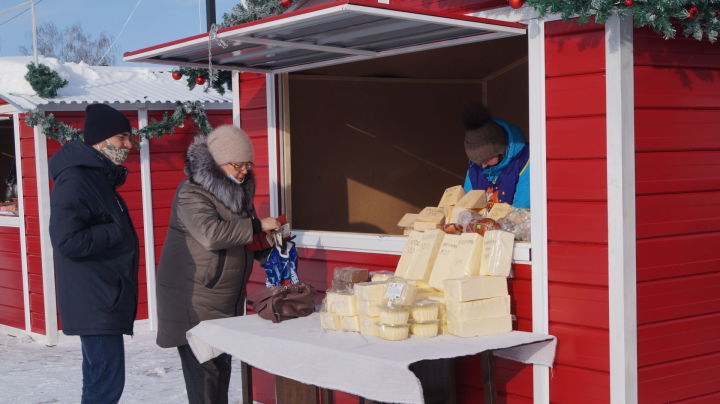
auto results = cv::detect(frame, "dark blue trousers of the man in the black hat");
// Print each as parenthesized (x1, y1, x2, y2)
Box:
(80, 335, 125, 404)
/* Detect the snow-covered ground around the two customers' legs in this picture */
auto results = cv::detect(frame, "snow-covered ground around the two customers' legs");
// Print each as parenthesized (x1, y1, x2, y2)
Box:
(0, 329, 253, 404)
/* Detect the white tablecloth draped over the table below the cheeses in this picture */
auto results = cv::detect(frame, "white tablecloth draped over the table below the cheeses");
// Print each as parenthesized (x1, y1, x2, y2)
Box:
(187, 313, 556, 403)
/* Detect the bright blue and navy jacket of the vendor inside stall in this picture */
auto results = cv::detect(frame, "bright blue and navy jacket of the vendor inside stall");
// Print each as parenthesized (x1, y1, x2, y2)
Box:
(464, 119, 530, 208)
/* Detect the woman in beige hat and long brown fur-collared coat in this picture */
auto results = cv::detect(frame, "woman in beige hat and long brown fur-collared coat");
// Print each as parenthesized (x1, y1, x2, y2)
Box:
(157, 125, 280, 404)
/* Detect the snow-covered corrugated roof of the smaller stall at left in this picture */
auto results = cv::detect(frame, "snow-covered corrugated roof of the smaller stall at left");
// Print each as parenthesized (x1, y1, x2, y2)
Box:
(0, 56, 232, 111)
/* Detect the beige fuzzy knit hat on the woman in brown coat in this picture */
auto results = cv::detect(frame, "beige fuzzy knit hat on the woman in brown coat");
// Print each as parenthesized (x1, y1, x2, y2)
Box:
(207, 125, 253, 166)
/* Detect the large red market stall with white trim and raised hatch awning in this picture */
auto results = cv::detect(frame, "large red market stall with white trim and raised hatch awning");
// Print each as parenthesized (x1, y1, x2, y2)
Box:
(125, 1, 720, 403)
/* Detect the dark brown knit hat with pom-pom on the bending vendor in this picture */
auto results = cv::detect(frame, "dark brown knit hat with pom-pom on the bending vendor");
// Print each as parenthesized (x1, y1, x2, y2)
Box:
(463, 105, 508, 165)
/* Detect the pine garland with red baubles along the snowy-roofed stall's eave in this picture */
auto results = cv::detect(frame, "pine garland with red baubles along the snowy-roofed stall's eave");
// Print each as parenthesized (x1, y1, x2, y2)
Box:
(25, 101, 212, 144)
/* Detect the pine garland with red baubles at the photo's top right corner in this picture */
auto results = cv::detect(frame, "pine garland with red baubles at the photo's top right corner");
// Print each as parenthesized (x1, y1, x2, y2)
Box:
(527, 0, 720, 42)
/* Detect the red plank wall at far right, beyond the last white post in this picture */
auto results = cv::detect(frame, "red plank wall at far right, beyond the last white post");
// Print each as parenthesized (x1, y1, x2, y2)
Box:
(634, 26, 720, 403)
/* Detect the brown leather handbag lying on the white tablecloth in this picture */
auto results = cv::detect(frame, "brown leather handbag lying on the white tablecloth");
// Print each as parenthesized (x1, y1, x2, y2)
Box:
(248, 282, 315, 323)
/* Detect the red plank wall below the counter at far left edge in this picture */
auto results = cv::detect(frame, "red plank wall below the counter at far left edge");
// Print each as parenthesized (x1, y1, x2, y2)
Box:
(0, 227, 25, 330)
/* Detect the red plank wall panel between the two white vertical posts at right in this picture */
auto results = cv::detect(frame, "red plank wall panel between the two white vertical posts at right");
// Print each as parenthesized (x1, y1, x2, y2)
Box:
(545, 21, 610, 403)
